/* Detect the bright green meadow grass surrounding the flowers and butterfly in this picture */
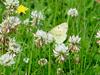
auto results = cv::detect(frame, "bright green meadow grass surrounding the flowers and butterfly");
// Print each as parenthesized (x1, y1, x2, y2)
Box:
(0, 0, 100, 75)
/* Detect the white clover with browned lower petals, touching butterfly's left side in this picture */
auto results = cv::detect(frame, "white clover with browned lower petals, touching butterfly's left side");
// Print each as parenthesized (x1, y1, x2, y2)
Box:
(34, 30, 54, 47)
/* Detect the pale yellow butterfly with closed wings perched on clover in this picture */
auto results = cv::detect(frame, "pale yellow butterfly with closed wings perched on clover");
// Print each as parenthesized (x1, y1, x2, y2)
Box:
(49, 22, 68, 44)
